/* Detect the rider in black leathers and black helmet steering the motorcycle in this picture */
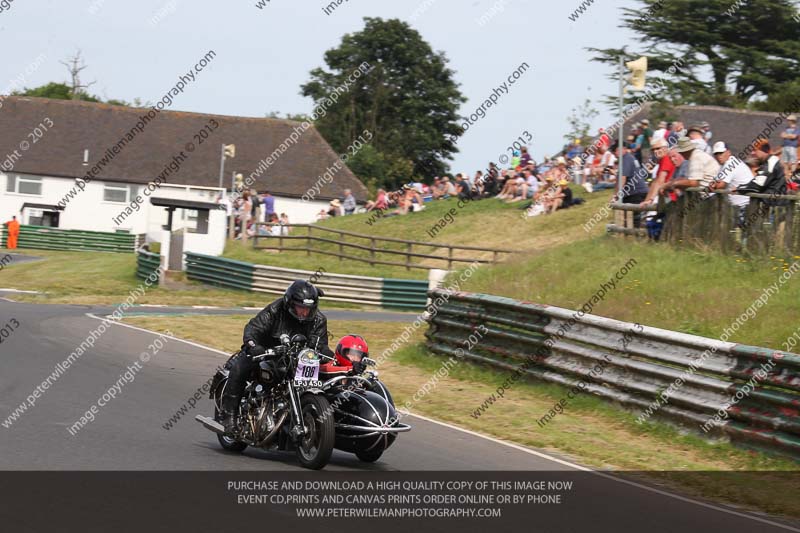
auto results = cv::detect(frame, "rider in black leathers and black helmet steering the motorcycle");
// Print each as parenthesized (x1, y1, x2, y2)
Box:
(221, 280, 334, 435)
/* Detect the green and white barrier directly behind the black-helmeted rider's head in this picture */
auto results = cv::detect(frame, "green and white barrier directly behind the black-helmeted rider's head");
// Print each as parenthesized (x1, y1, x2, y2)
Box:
(186, 253, 428, 309)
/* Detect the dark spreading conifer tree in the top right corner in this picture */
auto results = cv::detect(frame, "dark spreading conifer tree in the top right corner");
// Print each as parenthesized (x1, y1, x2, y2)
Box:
(589, 0, 800, 107)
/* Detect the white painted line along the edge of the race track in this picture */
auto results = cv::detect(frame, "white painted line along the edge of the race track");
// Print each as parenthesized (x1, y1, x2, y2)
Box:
(86, 313, 800, 533)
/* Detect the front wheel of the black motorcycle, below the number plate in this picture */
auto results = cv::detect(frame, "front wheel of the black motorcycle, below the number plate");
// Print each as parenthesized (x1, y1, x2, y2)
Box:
(297, 394, 336, 470)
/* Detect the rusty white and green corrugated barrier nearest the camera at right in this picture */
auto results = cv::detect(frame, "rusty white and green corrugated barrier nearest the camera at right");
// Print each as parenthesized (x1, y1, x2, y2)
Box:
(426, 289, 800, 458)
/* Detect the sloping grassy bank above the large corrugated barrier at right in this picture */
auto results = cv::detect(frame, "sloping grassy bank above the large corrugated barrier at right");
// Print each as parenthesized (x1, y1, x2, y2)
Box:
(456, 236, 800, 349)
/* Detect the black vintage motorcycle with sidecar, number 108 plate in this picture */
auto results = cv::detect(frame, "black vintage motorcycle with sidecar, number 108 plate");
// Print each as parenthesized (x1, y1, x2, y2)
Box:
(195, 335, 411, 470)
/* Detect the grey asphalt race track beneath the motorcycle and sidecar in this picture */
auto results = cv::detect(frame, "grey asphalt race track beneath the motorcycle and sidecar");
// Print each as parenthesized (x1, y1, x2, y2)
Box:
(0, 300, 800, 532)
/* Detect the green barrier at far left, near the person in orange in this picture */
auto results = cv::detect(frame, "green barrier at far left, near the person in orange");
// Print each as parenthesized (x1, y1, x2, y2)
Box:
(0, 225, 139, 253)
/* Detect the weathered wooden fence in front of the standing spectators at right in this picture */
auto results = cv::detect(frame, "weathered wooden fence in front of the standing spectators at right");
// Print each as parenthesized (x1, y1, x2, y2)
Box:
(606, 188, 800, 255)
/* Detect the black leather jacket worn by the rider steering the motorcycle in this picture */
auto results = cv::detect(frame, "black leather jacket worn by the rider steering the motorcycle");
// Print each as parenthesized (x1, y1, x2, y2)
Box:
(242, 298, 333, 357)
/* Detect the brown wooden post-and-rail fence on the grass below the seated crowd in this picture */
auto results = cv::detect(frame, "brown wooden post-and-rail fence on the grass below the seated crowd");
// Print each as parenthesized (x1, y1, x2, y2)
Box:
(252, 223, 515, 270)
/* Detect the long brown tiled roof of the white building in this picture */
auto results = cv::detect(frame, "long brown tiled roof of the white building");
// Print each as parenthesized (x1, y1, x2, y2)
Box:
(0, 96, 367, 201)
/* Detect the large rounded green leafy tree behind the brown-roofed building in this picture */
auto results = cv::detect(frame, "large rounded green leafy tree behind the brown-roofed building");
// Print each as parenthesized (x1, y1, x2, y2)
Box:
(301, 17, 466, 187)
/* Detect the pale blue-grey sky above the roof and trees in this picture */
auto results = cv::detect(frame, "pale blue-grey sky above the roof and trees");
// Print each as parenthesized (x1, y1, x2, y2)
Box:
(0, 0, 635, 173)
